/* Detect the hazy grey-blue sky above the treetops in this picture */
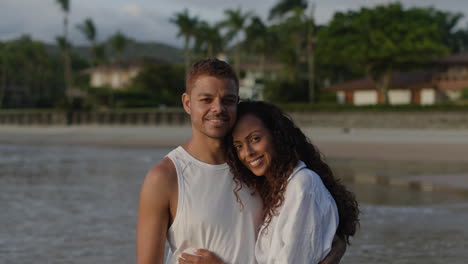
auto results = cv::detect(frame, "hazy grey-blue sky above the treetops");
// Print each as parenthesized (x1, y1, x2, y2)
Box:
(0, 0, 468, 47)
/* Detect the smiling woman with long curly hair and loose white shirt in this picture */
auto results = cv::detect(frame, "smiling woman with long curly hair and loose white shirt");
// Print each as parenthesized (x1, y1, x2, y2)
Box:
(227, 101, 359, 264)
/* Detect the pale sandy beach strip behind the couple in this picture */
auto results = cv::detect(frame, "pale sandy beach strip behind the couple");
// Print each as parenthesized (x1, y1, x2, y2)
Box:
(0, 125, 468, 196)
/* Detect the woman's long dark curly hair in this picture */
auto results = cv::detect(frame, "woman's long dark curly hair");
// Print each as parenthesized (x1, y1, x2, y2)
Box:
(226, 101, 359, 244)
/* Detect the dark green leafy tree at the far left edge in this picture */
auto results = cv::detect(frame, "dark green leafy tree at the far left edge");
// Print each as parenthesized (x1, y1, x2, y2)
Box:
(0, 36, 64, 108)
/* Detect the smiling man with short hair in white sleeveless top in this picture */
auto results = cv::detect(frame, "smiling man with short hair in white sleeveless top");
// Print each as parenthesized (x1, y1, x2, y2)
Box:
(137, 59, 345, 264)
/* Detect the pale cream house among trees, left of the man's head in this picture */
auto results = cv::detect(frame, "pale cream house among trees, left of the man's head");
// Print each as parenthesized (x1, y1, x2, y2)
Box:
(84, 58, 162, 90)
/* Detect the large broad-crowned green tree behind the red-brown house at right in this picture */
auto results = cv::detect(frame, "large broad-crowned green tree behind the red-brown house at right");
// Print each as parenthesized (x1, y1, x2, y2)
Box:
(317, 3, 448, 103)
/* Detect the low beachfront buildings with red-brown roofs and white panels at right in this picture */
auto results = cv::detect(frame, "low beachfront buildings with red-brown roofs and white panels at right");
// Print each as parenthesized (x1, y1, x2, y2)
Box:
(323, 53, 468, 105)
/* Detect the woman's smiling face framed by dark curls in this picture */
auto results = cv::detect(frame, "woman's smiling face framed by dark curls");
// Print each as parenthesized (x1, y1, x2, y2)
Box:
(232, 114, 274, 176)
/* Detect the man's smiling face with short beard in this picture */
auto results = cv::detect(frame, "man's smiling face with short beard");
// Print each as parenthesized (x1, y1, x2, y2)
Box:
(182, 75, 238, 139)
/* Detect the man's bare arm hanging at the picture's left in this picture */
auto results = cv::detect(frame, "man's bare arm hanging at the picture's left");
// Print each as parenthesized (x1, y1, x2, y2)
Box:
(137, 158, 177, 264)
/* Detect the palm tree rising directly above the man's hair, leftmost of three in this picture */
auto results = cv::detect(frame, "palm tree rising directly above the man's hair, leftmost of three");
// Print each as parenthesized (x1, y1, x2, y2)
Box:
(169, 9, 198, 72)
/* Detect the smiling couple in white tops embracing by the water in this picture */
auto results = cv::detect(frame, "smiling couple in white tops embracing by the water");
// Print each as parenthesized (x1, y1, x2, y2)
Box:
(137, 59, 359, 264)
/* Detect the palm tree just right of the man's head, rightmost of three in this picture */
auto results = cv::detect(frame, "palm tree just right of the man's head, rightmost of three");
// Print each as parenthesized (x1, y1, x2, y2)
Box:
(220, 8, 251, 75)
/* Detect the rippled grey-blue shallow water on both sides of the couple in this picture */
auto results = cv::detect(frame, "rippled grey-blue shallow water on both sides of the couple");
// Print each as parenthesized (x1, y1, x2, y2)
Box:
(0, 145, 468, 264)
